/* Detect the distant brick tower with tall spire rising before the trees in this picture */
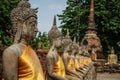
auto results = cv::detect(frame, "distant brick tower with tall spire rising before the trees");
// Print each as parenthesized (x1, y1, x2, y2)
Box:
(81, 0, 101, 57)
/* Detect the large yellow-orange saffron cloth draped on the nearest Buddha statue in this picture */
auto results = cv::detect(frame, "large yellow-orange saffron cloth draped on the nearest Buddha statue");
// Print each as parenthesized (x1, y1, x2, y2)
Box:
(18, 46, 45, 80)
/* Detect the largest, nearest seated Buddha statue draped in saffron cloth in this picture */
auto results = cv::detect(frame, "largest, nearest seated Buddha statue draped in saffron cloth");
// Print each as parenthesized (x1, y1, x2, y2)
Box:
(2, 0, 45, 80)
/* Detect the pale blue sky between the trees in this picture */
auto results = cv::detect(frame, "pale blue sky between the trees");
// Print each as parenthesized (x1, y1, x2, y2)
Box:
(29, 0, 67, 33)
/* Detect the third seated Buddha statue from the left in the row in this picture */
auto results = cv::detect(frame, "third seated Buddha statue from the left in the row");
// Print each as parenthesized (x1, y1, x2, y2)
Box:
(62, 30, 79, 80)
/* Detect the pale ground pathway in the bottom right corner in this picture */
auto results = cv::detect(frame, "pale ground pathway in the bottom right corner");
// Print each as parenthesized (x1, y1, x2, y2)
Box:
(97, 73, 120, 80)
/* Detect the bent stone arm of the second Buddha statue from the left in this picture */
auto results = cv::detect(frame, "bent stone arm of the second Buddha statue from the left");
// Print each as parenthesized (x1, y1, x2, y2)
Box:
(46, 57, 67, 80)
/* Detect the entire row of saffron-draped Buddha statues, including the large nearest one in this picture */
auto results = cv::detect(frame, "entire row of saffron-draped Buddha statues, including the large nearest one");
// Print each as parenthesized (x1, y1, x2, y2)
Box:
(2, 0, 96, 80)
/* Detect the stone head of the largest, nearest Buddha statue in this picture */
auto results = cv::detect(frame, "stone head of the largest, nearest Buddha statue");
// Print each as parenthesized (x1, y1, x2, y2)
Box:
(10, 0, 38, 43)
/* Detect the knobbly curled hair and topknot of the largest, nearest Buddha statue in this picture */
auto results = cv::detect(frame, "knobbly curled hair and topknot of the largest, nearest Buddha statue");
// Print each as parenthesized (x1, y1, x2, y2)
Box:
(10, 0, 37, 27)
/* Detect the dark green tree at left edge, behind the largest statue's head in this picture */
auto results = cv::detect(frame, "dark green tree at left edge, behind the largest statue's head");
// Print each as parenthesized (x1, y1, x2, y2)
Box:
(0, 0, 19, 46)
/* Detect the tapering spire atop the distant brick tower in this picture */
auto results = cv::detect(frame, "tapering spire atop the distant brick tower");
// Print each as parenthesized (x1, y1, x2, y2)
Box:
(87, 0, 96, 30)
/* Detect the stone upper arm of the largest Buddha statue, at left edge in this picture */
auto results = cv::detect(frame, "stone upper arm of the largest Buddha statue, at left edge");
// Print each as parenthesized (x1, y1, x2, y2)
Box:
(2, 49, 18, 80)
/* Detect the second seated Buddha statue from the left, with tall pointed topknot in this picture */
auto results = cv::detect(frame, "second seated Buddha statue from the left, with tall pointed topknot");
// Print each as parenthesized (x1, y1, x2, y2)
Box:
(46, 16, 68, 80)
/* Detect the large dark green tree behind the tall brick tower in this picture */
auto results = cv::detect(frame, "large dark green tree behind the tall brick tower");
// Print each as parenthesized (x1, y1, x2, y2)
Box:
(58, 0, 120, 57)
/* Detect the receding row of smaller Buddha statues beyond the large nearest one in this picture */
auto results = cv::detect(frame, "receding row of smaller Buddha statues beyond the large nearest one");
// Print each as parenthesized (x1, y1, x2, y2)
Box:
(46, 17, 96, 80)
